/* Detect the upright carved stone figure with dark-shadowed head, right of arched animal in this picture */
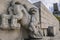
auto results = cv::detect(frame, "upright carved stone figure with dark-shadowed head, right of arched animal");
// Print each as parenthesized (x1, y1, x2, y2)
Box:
(29, 7, 41, 38)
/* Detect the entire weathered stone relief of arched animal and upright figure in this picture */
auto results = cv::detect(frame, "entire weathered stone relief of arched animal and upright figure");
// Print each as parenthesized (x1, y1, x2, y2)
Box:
(0, 2, 41, 38)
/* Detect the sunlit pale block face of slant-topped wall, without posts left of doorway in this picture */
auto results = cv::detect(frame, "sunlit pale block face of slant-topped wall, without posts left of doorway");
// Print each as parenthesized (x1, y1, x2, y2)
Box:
(41, 1, 59, 35)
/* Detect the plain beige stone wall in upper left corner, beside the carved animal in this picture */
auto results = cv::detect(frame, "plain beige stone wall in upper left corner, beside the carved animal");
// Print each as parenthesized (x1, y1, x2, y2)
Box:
(0, 0, 11, 14)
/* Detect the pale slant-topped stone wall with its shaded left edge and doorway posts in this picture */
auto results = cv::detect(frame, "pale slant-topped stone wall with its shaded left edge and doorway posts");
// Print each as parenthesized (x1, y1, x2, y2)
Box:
(34, 2, 59, 36)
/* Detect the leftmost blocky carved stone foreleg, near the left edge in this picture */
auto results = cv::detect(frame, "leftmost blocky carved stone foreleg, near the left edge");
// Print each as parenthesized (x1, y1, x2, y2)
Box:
(0, 14, 9, 29)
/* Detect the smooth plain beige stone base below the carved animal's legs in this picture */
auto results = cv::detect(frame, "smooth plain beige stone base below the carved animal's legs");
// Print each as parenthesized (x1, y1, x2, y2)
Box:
(0, 30, 20, 40)
